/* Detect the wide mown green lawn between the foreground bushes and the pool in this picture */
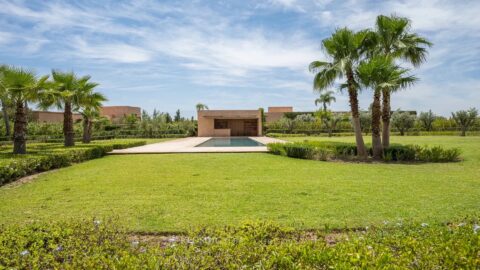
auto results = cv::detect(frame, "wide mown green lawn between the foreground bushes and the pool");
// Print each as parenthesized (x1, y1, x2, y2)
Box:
(0, 136, 480, 231)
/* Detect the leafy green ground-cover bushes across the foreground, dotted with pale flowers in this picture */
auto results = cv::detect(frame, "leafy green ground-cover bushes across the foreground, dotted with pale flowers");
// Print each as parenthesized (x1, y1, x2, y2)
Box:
(0, 218, 480, 269)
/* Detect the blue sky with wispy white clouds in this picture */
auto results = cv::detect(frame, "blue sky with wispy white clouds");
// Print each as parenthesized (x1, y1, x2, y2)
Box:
(0, 0, 480, 116)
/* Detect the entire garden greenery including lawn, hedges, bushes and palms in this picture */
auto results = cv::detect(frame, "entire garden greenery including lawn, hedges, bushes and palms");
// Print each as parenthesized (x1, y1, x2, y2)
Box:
(0, 12, 480, 269)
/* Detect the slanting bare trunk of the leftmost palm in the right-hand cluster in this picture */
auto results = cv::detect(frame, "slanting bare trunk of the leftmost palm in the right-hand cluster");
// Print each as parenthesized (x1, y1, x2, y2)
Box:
(347, 71, 367, 159)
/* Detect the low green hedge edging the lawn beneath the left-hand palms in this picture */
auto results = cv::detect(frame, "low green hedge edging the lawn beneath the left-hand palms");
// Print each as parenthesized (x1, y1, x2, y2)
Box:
(0, 141, 146, 186)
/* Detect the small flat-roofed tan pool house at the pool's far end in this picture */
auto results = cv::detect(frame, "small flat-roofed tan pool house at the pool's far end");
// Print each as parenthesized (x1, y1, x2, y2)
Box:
(198, 110, 262, 137)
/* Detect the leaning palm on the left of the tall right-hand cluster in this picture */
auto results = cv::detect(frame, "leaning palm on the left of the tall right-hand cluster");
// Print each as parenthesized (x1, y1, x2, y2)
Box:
(309, 28, 368, 158)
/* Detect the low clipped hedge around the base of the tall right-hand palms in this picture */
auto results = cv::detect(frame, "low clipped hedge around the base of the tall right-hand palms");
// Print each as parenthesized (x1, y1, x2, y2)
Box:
(267, 141, 461, 162)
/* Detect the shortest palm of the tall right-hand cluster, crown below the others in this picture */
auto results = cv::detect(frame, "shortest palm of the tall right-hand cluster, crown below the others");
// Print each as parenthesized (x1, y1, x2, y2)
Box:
(356, 56, 417, 159)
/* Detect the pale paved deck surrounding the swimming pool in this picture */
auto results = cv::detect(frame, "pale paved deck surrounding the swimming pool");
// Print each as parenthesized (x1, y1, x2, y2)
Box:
(110, 137, 285, 155)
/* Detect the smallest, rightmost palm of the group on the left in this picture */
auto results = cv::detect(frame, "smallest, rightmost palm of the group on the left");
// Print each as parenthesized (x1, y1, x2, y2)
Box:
(80, 88, 107, 143)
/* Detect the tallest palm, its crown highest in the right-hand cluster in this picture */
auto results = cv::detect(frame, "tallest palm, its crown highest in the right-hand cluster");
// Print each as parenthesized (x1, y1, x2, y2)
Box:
(370, 15, 432, 147)
